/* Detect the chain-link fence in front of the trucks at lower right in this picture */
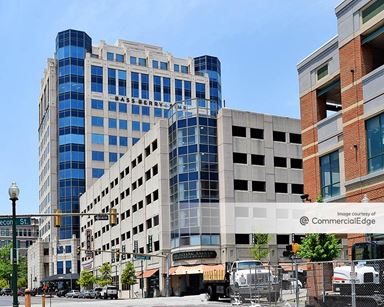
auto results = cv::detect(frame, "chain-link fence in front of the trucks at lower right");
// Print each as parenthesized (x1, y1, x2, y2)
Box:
(231, 260, 384, 307)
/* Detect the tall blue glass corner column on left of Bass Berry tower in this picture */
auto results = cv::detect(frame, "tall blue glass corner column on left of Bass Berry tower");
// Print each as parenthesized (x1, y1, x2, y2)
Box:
(55, 30, 92, 239)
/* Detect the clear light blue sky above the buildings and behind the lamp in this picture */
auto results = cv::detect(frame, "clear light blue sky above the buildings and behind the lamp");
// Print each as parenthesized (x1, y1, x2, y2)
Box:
(0, 0, 340, 214)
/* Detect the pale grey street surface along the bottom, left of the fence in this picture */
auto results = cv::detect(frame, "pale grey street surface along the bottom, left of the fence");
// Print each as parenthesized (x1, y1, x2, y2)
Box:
(0, 295, 230, 307)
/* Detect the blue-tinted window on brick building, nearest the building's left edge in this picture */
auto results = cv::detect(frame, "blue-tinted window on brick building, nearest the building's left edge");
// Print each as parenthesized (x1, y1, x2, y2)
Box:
(320, 151, 340, 198)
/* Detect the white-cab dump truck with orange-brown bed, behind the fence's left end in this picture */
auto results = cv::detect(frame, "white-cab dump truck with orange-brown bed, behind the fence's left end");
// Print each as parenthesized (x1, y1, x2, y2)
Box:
(203, 260, 281, 302)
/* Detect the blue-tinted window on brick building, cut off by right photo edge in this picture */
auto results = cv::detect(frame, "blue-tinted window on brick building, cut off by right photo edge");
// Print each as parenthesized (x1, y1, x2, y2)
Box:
(365, 114, 384, 173)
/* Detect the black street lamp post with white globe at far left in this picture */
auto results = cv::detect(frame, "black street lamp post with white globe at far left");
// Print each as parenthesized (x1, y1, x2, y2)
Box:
(8, 182, 20, 307)
